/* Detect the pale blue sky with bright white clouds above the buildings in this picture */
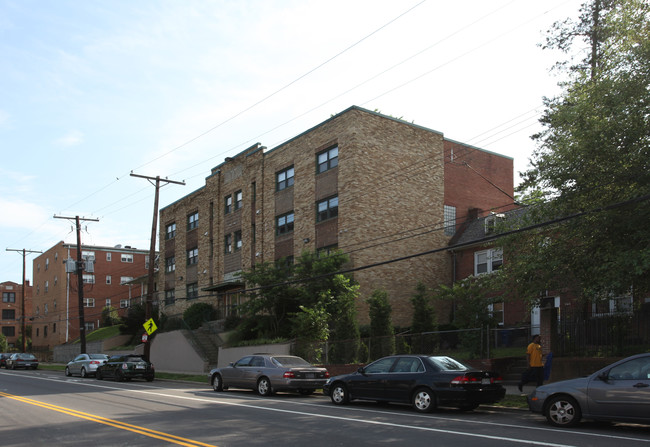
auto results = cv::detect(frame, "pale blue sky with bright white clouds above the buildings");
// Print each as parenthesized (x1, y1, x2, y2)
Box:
(0, 0, 581, 283)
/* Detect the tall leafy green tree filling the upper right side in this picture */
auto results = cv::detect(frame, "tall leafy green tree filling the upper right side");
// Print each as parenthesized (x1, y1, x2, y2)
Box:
(503, 0, 650, 308)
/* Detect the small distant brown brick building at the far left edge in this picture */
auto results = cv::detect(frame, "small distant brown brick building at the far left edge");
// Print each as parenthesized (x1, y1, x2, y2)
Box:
(0, 281, 32, 349)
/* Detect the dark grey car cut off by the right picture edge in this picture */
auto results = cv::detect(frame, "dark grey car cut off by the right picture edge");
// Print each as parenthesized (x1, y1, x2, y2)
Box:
(528, 353, 650, 427)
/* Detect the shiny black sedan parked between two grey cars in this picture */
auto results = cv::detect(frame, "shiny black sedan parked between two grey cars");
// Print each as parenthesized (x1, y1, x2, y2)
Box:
(323, 355, 506, 413)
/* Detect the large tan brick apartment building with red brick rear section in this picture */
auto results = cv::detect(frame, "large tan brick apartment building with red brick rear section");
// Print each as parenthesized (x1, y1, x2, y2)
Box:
(158, 106, 513, 326)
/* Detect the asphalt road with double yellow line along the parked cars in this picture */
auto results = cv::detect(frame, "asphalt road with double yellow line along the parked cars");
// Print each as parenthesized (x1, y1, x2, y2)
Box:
(0, 370, 650, 447)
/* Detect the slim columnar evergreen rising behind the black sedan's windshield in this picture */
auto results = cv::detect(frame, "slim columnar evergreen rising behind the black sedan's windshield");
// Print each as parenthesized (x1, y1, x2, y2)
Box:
(366, 290, 395, 359)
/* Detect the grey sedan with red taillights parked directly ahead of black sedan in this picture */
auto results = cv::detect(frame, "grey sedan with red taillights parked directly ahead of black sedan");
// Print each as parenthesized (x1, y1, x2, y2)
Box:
(208, 354, 329, 396)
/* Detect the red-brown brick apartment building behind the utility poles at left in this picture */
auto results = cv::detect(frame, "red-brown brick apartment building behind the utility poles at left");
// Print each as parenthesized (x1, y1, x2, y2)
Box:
(31, 241, 149, 350)
